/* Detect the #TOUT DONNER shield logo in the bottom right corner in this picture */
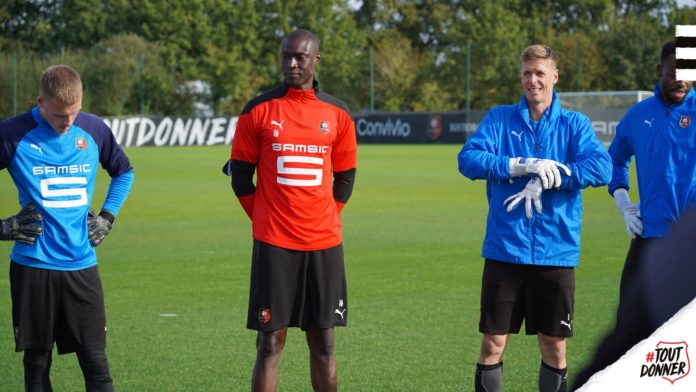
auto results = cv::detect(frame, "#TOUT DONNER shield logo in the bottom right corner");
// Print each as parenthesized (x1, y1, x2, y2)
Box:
(640, 341, 691, 384)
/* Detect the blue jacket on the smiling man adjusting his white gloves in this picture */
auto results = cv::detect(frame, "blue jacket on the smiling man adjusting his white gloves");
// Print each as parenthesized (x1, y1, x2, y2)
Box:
(458, 91, 611, 267)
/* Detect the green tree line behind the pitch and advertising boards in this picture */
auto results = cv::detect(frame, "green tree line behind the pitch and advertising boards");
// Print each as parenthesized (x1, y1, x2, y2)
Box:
(0, 0, 696, 118)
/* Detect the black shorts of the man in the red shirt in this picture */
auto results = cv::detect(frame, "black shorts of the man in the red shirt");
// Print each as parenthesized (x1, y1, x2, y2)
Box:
(247, 240, 348, 331)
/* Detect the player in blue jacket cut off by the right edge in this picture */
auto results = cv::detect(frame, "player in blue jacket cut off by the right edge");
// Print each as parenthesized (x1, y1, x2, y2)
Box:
(575, 41, 696, 387)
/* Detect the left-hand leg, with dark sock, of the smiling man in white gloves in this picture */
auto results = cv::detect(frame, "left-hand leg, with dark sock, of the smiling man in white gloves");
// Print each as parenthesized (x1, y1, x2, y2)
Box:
(474, 334, 510, 392)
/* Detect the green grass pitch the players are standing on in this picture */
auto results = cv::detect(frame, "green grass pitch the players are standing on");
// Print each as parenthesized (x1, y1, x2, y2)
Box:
(0, 145, 635, 392)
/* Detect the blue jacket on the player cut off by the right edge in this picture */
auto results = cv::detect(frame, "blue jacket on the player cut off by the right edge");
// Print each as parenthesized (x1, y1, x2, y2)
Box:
(609, 83, 696, 238)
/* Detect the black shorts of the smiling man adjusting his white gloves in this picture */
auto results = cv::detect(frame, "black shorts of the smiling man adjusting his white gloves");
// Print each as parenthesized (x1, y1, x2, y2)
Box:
(479, 259, 575, 337)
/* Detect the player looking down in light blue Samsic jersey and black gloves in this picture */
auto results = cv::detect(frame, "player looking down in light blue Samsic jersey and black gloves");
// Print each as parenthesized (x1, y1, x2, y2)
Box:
(0, 65, 133, 391)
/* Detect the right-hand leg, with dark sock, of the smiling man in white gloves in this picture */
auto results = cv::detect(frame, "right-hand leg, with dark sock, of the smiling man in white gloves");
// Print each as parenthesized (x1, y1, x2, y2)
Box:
(537, 332, 568, 392)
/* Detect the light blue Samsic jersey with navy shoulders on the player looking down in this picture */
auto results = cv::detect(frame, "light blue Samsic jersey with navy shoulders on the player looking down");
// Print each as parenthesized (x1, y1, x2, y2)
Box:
(0, 107, 133, 271)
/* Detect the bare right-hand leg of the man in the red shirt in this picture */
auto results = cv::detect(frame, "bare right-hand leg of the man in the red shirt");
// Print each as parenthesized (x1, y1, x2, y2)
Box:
(307, 327, 338, 392)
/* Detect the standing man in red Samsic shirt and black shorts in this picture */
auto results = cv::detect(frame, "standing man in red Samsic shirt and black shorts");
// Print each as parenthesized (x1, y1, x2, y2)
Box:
(224, 30, 357, 391)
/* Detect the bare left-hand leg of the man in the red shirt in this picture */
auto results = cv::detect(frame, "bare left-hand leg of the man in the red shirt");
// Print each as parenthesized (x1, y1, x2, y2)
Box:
(251, 328, 288, 392)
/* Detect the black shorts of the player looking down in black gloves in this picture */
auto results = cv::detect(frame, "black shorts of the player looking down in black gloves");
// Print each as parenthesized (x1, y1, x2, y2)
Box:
(10, 262, 106, 354)
